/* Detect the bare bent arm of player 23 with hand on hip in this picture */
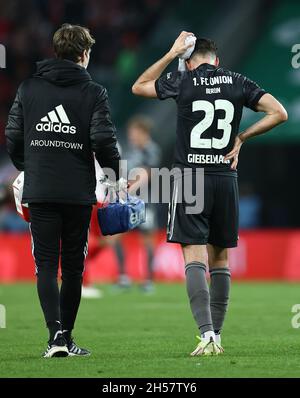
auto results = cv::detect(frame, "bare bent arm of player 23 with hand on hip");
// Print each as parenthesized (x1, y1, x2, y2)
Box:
(225, 94, 288, 169)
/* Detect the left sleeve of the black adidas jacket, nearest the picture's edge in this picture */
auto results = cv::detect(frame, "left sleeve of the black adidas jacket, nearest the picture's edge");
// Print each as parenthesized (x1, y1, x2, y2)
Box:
(5, 88, 24, 171)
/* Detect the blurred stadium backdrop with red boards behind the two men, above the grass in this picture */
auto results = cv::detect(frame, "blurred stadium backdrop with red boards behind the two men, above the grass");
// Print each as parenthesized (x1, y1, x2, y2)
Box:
(0, 0, 300, 283)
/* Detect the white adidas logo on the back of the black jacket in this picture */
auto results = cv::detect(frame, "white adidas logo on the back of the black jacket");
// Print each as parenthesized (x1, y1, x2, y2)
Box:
(35, 104, 76, 134)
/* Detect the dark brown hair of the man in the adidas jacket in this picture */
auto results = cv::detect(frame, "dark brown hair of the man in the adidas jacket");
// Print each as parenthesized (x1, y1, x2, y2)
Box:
(53, 23, 95, 62)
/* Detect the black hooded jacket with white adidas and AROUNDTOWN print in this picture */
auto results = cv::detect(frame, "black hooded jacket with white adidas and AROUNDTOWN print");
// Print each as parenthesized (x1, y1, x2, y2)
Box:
(5, 59, 120, 204)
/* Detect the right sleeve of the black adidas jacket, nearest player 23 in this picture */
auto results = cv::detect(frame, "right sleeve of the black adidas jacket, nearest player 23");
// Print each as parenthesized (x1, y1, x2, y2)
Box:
(90, 89, 120, 180)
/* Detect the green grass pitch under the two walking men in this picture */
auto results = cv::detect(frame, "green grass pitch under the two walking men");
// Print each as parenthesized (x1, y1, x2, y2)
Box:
(0, 283, 300, 378)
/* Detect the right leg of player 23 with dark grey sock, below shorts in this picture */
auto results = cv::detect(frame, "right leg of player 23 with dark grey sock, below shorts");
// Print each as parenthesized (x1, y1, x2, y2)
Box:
(207, 245, 230, 352)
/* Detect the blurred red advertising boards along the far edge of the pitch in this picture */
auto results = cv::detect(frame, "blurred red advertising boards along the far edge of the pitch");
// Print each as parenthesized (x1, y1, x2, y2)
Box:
(0, 229, 300, 283)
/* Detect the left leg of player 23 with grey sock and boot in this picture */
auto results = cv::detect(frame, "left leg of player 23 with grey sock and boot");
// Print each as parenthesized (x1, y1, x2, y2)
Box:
(182, 245, 220, 356)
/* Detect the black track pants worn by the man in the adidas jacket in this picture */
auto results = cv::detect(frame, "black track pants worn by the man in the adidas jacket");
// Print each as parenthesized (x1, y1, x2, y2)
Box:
(29, 203, 92, 330)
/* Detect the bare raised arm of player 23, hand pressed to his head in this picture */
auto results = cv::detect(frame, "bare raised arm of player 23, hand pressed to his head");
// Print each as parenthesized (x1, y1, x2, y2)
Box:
(132, 31, 193, 98)
